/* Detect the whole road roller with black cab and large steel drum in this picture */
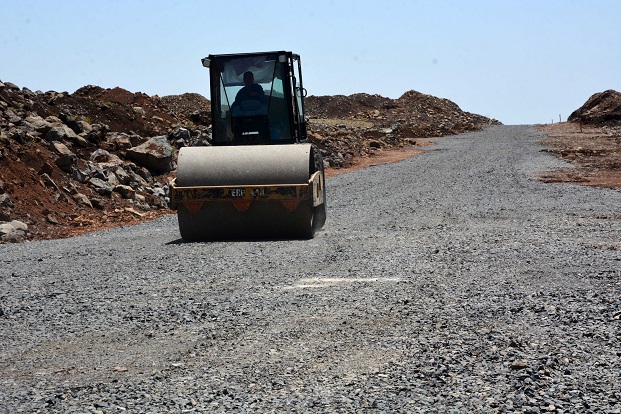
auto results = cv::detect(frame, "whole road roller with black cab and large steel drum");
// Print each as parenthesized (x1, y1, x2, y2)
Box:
(171, 51, 326, 241)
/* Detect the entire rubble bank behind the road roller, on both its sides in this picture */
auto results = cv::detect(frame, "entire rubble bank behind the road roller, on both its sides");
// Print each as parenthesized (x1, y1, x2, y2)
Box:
(0, 82, 499, 242)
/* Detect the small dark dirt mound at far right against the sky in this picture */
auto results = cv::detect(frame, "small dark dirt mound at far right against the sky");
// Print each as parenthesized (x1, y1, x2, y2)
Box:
(567, 89, 621, 126)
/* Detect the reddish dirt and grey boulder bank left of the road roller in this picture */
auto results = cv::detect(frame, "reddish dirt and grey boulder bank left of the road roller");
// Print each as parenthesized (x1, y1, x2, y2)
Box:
(0, 82, 211, 242)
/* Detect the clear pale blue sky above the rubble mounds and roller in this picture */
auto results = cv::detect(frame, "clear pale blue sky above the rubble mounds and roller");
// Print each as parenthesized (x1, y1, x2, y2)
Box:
(0, 0, 621, 124)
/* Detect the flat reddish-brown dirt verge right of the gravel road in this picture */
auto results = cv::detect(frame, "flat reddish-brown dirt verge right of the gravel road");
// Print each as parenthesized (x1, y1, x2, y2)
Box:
(540, 122, 621, 188)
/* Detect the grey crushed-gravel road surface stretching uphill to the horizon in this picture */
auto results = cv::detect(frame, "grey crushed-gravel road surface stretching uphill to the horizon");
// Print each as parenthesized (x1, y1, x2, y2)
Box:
(0, 126, 621, 413)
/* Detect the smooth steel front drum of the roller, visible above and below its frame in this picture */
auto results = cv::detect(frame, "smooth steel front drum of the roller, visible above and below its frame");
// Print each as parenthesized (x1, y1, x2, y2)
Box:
(176, 144, 325, 241)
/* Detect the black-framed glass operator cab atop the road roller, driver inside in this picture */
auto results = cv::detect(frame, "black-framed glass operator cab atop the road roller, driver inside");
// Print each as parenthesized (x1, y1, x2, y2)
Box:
(202, 52, 306, 145)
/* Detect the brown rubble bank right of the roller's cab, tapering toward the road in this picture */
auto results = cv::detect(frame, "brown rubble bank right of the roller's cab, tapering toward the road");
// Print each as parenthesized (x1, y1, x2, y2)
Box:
(305, 91, 500, 167)
